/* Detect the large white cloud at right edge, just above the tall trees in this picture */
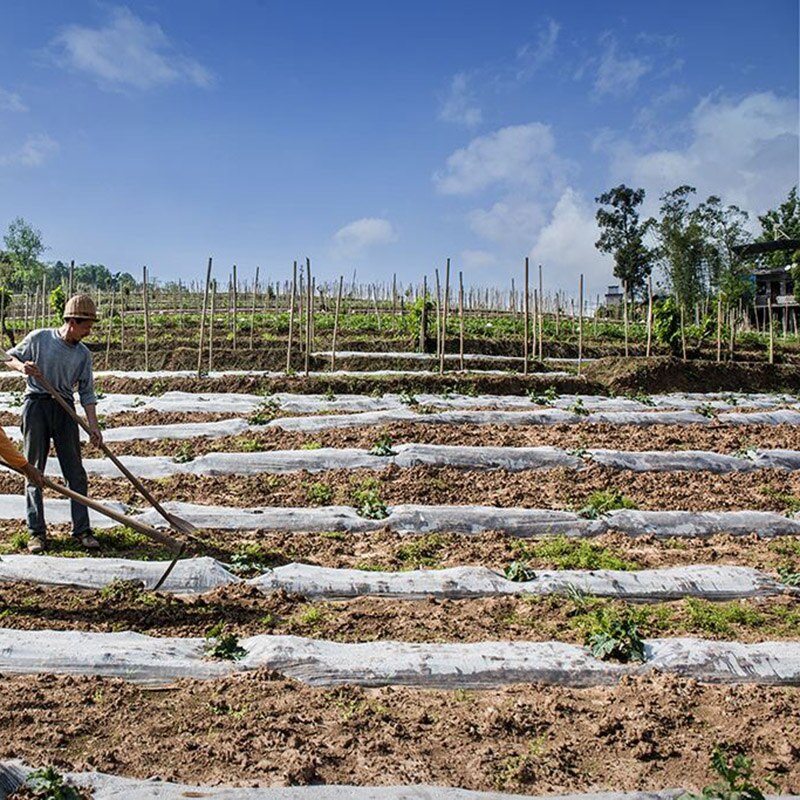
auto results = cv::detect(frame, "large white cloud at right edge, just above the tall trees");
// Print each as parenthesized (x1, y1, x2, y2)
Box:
(601, 92, 798, 219)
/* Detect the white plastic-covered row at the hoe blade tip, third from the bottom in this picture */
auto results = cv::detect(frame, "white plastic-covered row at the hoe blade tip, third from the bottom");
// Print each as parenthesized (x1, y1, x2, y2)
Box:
(0, 555, 792, 602)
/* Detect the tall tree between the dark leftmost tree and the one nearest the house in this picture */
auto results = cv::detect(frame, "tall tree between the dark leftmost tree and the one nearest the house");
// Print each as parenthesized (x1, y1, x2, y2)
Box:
(652, 185, 706, 309)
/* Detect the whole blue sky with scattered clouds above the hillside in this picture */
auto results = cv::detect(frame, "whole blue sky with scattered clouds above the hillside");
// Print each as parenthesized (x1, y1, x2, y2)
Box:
(0, 0, 799, 293)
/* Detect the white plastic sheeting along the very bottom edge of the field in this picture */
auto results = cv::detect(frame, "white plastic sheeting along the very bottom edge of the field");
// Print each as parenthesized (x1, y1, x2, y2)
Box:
(0, 761, 700, 800)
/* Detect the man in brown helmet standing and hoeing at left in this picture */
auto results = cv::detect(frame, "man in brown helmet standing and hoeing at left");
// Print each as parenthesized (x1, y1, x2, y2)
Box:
(6, 294, 103, 553)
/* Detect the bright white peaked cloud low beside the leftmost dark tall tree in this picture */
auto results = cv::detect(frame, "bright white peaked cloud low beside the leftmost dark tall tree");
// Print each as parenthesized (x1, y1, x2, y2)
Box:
(530, 187, 613, 296)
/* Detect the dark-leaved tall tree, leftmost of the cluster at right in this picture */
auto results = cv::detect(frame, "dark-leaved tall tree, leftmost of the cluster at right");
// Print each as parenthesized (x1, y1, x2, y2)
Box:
(594, 183, 653, 297)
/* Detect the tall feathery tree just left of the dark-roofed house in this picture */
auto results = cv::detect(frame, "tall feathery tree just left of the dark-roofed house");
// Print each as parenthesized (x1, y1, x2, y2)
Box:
(694, 195, 752, 303)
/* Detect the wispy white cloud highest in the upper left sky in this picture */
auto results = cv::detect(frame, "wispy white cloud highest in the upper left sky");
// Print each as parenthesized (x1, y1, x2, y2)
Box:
(51, 7, 213, 89)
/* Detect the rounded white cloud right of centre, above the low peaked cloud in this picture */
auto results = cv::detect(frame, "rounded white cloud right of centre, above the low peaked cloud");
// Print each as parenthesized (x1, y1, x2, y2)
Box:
(433, 122, 569, 194)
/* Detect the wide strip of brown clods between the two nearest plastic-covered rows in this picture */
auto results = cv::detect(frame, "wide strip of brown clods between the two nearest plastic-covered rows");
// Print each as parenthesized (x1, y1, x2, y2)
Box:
(0, 672, 800, 794)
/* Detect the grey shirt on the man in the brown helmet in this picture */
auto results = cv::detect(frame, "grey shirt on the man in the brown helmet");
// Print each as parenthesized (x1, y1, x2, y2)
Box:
(8, 328, 97, 406)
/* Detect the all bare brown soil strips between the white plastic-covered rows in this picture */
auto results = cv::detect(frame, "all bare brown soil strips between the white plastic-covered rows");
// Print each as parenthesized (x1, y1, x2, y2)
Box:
(0, 366, 800, 794)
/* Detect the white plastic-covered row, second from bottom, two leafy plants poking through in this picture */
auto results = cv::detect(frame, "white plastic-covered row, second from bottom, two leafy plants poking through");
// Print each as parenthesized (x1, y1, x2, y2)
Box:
(0, 628, 800, 689)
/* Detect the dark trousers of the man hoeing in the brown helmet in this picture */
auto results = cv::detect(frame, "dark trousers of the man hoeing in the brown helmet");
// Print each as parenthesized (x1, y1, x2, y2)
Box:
(22, 395, 91, 536)
